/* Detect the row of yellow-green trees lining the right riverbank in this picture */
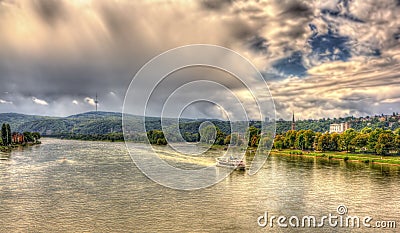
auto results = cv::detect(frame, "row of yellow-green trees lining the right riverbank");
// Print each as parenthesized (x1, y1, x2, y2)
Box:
(273, 127, 400, 155)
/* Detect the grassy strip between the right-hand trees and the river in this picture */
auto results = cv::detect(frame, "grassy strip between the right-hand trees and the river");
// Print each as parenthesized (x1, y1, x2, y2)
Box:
(271, 150, 400, 166)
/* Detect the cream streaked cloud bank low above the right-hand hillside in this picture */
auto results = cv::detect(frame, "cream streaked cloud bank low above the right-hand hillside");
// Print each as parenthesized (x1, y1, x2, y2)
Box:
(270, 57, 400, 119)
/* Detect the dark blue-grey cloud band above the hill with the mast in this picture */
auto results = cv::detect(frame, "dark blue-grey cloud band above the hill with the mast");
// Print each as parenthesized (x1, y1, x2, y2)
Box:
(0, 50, 132, 100)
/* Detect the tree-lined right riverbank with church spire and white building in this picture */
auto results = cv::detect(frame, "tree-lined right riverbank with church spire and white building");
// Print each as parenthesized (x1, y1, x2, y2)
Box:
(271, 114, 400, 165)
